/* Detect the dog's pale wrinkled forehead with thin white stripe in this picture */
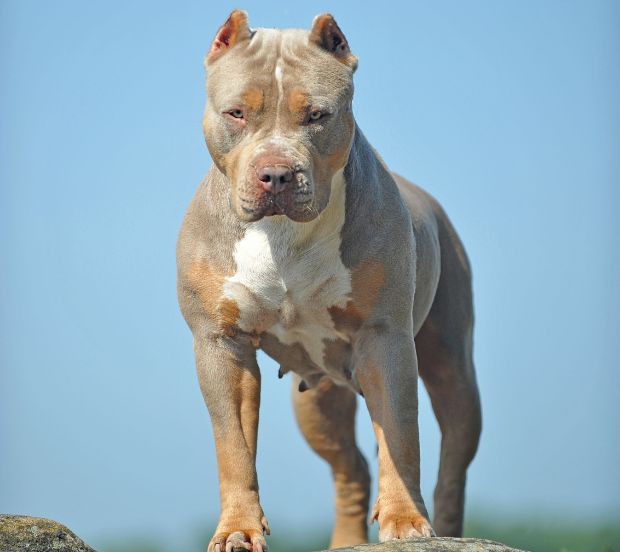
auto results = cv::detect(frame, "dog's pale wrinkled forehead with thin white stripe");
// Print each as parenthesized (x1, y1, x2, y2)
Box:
(207, 28, 352, 100)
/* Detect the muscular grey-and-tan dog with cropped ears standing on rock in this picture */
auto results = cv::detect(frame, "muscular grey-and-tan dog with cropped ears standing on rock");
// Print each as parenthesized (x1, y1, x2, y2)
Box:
(177, 11, 481, 552)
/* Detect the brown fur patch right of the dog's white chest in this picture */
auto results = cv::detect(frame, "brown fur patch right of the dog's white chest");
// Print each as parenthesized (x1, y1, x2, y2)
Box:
(328, 259, 385, 332)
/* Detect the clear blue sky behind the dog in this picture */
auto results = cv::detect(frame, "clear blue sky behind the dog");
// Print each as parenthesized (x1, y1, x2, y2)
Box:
(0, 0, 620, 545)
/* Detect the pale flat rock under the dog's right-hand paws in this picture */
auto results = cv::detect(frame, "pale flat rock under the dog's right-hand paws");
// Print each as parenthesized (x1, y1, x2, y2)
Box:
(323, 537, 525, 552)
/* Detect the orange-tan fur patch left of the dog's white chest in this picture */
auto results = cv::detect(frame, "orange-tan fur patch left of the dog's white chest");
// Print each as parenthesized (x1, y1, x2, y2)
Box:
(187, 259, 239, 337)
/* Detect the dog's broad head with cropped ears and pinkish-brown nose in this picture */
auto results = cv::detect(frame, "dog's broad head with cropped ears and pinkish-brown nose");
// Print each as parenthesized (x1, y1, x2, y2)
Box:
(203, 11, 357, 222)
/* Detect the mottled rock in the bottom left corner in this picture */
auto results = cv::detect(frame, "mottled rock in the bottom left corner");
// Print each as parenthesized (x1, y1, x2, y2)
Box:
(0, 515, 95, 552)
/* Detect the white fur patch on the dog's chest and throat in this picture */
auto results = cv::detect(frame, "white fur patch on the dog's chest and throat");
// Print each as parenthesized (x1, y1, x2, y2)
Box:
(224, 171, 351, 369)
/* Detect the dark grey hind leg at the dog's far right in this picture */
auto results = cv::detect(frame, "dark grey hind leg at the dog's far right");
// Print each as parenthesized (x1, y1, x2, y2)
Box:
(415, 219, 481, 537)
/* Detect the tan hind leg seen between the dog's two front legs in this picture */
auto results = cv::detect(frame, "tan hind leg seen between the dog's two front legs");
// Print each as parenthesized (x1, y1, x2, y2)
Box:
(292, 376, 370, 548)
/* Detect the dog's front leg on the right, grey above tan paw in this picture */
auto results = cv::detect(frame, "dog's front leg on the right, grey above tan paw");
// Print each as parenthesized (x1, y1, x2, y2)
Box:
(356, 328, 434, 542)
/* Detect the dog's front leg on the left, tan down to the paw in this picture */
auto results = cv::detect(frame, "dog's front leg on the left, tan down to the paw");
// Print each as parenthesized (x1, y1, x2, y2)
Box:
(194, 336, 269, 552)
